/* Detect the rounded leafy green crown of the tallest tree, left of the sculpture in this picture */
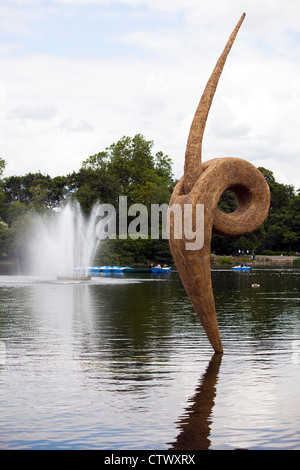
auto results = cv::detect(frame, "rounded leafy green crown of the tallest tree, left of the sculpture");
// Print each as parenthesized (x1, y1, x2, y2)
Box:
(76, 134, 174, 208)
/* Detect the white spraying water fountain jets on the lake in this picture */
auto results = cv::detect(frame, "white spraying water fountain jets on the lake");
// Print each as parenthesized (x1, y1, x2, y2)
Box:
(29, 202, 99, 280)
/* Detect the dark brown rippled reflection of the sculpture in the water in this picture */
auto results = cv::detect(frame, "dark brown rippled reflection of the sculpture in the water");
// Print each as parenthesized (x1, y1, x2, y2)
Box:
(170, 354, 222, 450)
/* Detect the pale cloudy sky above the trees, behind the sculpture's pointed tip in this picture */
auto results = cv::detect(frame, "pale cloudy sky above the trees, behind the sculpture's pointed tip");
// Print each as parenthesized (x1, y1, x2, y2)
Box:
(0, 0, 300, 190)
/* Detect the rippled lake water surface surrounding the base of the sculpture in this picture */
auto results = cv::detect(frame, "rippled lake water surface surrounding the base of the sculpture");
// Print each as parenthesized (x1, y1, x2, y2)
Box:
(0, 269, 300, 450)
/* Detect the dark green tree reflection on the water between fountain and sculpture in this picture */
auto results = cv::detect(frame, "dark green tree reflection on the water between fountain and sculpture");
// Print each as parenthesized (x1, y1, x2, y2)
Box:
(91, 277, 189, 354)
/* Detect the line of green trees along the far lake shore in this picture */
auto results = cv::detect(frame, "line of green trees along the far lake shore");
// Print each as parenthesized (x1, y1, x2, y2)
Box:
(0, 134, 300, 264)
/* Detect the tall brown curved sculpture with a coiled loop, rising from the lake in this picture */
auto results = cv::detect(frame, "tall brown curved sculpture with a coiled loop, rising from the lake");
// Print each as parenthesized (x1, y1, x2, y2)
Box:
(169, 13, 270, 353)
